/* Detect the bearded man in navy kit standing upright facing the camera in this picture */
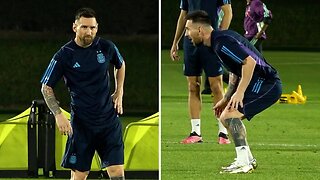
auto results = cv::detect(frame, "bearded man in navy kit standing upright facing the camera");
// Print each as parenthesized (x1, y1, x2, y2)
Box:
(41, 8, 125, 179)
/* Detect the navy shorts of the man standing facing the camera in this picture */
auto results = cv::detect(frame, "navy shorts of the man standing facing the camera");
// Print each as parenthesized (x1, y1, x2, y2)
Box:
(61, 118, 124, 172)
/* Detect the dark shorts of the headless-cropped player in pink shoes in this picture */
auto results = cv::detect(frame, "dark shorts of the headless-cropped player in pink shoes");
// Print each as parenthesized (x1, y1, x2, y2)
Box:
(183, 37, 223, 77)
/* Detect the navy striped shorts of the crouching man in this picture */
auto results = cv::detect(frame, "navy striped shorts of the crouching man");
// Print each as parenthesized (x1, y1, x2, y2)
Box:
(239, 77, 282, 121)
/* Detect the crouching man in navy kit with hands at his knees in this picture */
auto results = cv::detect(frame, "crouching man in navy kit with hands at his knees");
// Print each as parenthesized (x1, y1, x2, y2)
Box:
(186, 11, 282, 173)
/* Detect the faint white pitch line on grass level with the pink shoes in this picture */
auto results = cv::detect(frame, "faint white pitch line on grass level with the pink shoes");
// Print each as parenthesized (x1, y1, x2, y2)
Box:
(162, 141, 320, 148)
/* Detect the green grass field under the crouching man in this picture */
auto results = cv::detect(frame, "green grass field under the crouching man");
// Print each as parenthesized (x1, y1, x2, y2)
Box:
(161, 50, 320, 180)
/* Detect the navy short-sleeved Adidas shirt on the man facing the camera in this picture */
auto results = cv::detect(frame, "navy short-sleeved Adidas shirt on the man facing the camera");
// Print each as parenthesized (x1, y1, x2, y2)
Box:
(41, 37, 123, 126)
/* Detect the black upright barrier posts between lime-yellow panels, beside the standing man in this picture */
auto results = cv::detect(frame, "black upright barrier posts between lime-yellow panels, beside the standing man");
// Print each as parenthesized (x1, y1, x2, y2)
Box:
(28, 100, 56, 177)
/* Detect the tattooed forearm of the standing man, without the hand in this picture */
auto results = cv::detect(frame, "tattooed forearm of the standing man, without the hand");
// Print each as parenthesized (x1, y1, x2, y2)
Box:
(41, 84, 61, 115)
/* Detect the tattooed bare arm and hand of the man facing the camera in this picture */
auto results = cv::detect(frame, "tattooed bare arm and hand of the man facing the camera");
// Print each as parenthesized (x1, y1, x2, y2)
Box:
(41, 84, 72, 135)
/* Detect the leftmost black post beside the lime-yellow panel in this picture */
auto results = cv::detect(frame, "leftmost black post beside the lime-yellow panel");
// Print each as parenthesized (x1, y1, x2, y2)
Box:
(28, 100, 38, 177)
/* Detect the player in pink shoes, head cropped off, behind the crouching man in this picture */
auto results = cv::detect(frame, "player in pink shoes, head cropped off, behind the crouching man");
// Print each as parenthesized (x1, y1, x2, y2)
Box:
(170, 0, 232, 144)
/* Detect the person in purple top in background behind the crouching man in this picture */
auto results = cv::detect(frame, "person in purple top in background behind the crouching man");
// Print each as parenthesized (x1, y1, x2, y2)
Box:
(243, 0, 272, 52)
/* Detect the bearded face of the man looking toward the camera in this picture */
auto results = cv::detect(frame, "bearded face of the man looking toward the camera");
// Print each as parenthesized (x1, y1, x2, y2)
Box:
(73, 17, 98, 47)
